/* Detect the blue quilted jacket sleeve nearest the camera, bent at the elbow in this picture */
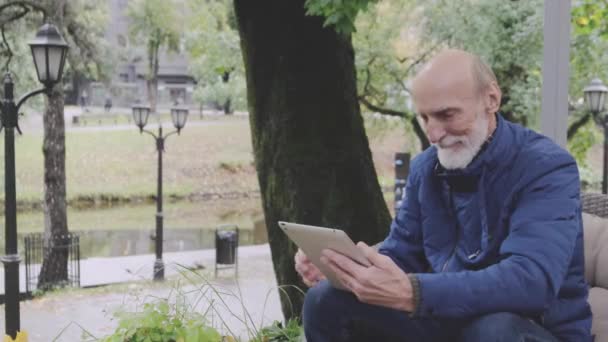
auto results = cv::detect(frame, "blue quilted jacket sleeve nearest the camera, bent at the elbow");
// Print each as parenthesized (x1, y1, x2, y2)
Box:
(416, 155, 581, 317)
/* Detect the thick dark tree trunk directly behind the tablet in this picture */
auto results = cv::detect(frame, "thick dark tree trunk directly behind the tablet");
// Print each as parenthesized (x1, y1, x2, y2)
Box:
(234, 0, 391, 318)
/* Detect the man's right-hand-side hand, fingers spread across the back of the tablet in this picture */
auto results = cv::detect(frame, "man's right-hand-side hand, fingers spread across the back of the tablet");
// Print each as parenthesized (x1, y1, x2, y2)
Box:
(321, 242, 414, 312)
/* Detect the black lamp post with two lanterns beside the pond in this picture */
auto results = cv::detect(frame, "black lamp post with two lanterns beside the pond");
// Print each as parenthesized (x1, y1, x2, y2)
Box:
(132, 105, 188, 280)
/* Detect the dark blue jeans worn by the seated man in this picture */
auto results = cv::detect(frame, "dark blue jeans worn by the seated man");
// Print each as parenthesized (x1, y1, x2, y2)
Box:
(303, 281, 557, 342)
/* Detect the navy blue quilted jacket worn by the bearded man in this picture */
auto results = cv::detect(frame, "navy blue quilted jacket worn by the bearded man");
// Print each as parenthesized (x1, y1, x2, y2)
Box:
(380, 115, 591, 342)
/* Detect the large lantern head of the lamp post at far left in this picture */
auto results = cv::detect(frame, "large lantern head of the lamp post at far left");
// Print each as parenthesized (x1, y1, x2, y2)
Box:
(29, 24, 68, 88)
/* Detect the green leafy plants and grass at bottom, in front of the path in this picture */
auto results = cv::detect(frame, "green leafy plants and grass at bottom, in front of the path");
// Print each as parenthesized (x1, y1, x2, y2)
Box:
(102, 265, 303, 342)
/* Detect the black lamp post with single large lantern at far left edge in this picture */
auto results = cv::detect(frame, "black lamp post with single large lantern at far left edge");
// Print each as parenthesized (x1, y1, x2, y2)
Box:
(0, 24, 68, 338)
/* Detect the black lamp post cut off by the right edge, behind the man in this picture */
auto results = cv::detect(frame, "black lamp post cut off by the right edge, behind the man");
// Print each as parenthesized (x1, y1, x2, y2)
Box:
(583, 78, 608, 194)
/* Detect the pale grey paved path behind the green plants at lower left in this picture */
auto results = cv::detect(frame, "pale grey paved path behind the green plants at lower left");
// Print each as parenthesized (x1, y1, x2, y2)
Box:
(0, 244, 283, 342)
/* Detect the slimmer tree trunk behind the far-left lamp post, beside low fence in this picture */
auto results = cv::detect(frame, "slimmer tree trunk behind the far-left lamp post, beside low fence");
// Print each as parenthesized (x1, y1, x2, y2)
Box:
(38, 77, 68, 289)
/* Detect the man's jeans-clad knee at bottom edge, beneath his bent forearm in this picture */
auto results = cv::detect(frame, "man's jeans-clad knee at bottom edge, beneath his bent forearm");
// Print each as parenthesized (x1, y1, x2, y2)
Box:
(462, 312, 552, 342)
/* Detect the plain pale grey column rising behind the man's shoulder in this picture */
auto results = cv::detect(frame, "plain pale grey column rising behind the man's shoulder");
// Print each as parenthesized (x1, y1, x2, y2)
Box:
(540, 0, 571, 147)
